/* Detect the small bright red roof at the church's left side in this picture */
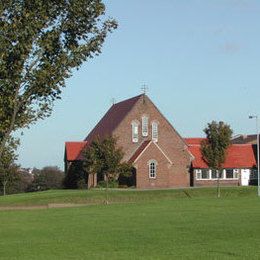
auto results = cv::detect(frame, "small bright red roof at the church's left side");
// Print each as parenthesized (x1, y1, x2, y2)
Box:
(65, 141, 88, 161)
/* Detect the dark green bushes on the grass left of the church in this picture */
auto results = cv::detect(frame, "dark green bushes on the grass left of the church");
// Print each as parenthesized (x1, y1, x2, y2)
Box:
(27, 166, 64, 191)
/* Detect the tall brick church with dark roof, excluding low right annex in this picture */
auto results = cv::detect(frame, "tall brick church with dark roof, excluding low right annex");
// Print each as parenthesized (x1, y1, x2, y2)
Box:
(65, 94, 193, 188)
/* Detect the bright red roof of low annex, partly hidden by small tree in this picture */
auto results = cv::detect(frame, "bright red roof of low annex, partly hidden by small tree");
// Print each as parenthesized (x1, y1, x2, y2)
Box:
(188, 144, 256, 168)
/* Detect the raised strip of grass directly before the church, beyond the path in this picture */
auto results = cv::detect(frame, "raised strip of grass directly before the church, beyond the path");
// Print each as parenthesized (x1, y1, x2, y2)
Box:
(0, 187, 257, 207)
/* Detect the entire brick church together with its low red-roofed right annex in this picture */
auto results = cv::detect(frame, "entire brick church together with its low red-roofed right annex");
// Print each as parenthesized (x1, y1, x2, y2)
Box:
(64, 94, 256, 188)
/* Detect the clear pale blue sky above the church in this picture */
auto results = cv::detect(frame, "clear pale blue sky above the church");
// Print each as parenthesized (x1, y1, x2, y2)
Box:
(18, 0, 260, 168)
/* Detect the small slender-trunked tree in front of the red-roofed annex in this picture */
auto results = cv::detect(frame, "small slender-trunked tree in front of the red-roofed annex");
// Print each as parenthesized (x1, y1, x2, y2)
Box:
(201, 121, 233, 197)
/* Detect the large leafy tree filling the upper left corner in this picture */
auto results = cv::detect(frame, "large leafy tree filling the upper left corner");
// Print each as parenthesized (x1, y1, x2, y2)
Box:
(0, 0, 117, 157)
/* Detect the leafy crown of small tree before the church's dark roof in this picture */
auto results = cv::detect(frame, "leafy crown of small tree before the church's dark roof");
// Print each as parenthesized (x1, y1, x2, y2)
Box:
(84, 137, 131, 185)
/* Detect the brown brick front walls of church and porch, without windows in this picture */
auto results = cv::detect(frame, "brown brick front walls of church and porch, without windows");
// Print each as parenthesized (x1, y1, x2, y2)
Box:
(113, 96, 191, 188)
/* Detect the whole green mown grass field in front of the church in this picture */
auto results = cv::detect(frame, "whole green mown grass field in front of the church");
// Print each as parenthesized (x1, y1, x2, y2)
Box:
(0, 188, 260, 259)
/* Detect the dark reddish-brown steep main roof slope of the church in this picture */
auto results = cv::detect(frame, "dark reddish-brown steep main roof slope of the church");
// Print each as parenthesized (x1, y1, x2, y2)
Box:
(85, 94, 143, 142)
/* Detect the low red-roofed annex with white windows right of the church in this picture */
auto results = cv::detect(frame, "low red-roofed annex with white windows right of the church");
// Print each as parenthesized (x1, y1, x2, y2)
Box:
(185, 138, 257, 186)
